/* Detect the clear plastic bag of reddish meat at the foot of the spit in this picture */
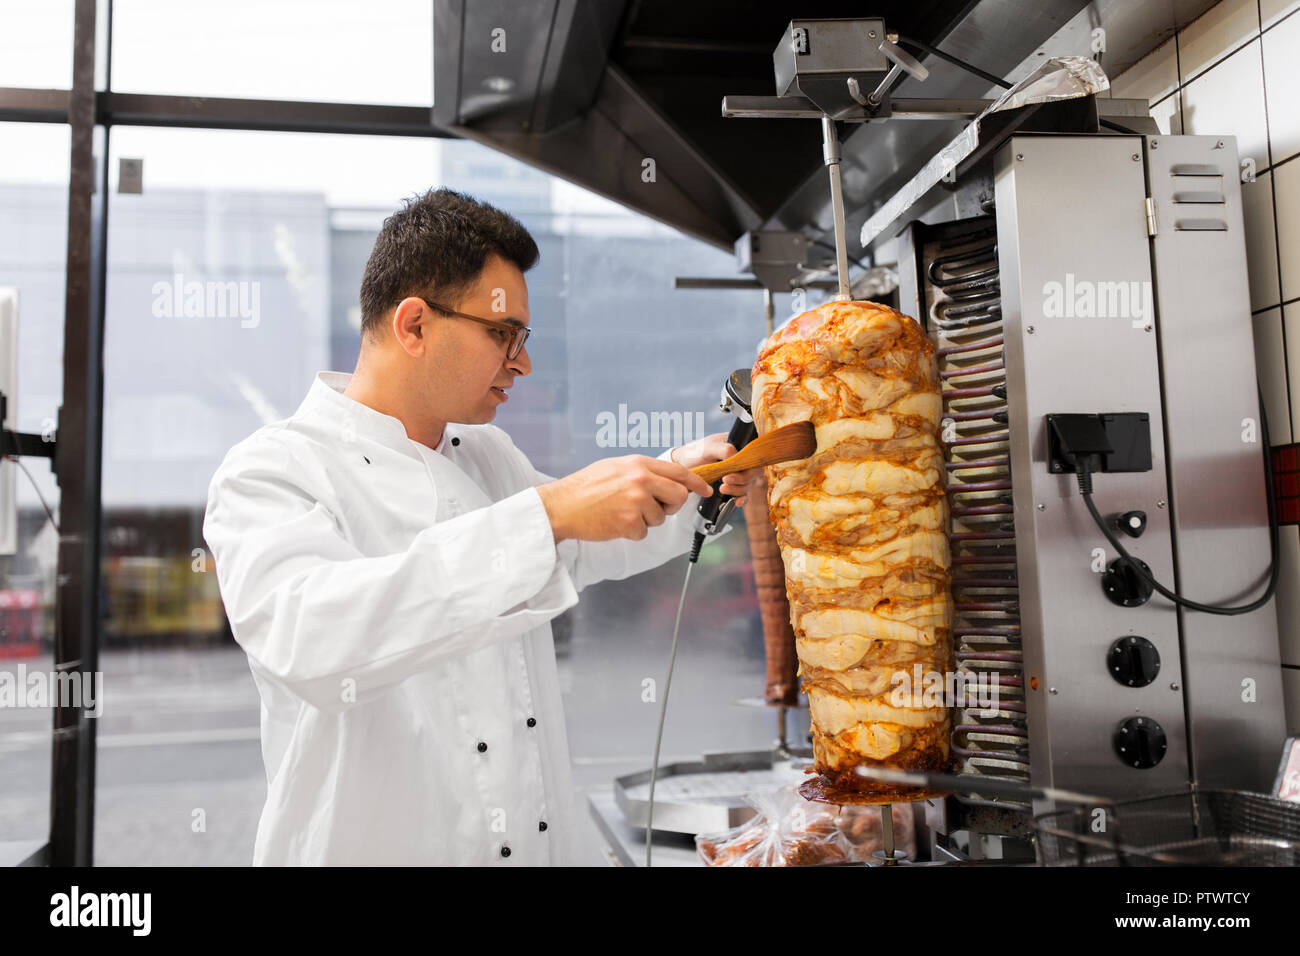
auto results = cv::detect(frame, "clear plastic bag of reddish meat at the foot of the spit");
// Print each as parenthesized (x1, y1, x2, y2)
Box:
(696, 787, 917, 866)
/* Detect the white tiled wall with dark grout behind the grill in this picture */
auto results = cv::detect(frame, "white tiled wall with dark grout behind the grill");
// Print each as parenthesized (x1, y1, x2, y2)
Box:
(1112, 0, 1300, 734)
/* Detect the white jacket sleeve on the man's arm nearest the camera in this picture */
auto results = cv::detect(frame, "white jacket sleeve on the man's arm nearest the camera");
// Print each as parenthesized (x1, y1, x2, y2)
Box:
(203, 441, 577, 711)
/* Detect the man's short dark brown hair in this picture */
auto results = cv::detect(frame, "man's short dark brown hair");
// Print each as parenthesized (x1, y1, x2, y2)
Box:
(361, 189, 540, 333)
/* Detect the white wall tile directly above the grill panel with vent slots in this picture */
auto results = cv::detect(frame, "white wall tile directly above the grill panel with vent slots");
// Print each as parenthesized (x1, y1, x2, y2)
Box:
(1183, 40, 1269, 169)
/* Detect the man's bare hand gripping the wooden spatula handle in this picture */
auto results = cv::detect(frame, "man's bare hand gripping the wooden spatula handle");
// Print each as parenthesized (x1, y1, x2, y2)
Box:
(537, 457, 731, 542)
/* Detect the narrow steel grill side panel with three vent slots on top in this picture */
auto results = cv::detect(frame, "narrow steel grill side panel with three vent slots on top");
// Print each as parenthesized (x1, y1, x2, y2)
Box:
(1144, 137, 1286, 791)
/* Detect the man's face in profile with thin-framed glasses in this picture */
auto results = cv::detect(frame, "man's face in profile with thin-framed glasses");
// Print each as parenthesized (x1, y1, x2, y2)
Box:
(423, 254, 533, 425)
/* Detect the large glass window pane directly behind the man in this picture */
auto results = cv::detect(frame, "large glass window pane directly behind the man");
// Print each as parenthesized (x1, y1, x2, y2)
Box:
(89, 127, 775, 865)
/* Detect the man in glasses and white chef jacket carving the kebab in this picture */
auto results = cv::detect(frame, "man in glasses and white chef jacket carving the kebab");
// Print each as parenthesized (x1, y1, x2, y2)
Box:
(203, 190, 750, 866)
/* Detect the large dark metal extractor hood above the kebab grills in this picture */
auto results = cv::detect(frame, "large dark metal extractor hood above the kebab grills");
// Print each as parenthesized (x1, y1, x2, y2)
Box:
(433, 0, 1213, 255)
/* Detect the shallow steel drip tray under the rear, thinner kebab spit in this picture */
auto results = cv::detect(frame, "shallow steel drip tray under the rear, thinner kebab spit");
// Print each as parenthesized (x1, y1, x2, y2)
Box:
(614, 750, 811, 834)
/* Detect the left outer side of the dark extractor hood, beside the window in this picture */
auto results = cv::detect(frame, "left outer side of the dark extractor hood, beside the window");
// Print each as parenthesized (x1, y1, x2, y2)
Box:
(433, 0, 759, 248)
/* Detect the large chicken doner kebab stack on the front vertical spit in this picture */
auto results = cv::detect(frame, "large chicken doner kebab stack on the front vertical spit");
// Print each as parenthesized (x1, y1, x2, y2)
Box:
(753, 302, 953, 804)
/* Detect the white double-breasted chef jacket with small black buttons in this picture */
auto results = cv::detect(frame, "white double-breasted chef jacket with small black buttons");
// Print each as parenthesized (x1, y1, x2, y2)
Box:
(203, 372, 699, 866)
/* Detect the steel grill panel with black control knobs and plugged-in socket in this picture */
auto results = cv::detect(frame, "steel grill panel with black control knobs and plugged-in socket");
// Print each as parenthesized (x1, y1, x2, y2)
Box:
(995, 135, 1188, 812)
